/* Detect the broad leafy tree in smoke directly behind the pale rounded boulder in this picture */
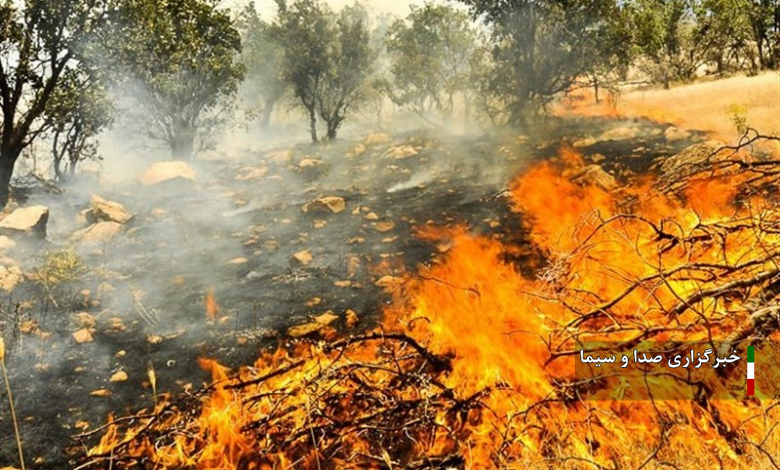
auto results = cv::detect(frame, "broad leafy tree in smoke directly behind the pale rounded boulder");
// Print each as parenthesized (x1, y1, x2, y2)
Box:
(103, 0, 244, 159)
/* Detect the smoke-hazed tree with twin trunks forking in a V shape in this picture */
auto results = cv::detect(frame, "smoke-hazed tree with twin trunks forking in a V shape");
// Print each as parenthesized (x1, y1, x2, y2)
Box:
(276, 0, 374, 142)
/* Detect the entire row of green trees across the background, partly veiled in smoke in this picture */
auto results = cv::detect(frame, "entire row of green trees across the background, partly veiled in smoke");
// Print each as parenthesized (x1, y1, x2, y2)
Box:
(0, 0, 780, 205)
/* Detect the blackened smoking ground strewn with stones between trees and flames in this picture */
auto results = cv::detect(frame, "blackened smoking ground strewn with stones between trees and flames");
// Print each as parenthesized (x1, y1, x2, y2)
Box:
(0, 114, 702, 469)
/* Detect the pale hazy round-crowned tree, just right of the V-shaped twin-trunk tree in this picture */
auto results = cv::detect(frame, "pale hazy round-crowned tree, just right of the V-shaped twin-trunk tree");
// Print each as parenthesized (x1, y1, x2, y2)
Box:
(386, 2, 478, 116)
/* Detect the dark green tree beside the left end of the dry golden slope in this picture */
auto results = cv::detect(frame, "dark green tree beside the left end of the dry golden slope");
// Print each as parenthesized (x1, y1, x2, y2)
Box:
(460, 0, 621, 123)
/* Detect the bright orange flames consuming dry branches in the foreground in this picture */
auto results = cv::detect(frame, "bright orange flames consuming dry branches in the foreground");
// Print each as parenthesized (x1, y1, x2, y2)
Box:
(80, 149, 780, 470)
